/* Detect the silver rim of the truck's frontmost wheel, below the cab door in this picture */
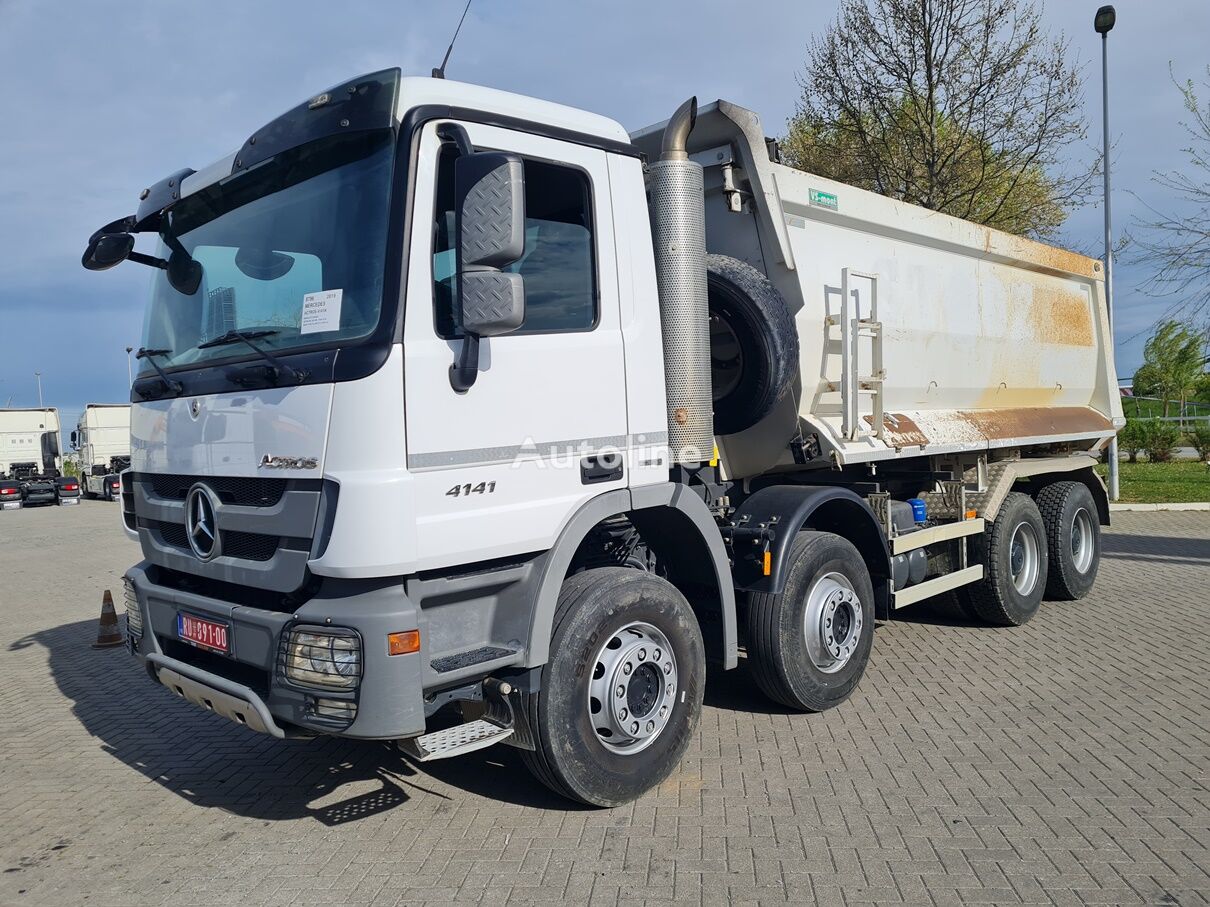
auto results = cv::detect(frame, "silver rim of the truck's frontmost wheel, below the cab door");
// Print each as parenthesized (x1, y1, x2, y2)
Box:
(588, 620, 678, 756)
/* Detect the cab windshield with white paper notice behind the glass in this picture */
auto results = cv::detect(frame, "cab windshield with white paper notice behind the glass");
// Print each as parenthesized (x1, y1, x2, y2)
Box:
(139, 129, 393, 375)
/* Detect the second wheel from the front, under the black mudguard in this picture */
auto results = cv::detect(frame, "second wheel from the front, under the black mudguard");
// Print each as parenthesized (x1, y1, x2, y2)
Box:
(748, 532, 874, 712)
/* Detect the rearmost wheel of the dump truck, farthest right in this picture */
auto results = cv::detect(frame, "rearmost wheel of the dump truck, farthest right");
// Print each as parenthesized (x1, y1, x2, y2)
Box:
(1037, 481, 1101, 601)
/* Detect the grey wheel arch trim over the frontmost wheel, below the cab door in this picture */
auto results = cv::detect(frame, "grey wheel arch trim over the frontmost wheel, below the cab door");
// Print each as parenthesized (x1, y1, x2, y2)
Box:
(529, 483, 738, 669)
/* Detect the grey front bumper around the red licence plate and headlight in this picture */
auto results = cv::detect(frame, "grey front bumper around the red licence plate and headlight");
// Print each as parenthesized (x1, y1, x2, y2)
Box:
(126, 561, 425, 740)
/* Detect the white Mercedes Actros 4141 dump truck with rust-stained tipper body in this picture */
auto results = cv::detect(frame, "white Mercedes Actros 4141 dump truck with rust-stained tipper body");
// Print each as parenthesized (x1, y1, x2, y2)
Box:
(83, 70, 1122, 805)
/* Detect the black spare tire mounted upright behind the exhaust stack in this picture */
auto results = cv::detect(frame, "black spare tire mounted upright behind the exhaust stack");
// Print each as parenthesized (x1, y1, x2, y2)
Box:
(705, 255, 799, 434)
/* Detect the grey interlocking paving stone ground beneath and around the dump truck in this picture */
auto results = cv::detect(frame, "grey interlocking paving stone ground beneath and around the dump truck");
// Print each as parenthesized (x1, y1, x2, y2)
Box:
(0, 502, 1210, 907)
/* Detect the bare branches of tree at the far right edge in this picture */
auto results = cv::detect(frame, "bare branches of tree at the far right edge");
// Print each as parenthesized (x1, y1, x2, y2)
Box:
(1134, 67, 1210, 330)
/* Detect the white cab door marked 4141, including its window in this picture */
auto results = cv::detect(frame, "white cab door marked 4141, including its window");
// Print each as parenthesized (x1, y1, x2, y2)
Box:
(404, 121, 629, 570)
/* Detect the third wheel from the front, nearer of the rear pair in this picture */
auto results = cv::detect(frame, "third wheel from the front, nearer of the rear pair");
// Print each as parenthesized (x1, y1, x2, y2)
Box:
(956, 491, 1049, 626)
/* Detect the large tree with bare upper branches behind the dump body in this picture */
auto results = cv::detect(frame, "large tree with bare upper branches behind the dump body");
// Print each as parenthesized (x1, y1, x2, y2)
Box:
(783, 0, 1095, 238)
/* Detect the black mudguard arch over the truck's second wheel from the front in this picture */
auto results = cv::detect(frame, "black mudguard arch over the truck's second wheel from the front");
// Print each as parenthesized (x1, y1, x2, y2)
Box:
(734, 485, 891, 619)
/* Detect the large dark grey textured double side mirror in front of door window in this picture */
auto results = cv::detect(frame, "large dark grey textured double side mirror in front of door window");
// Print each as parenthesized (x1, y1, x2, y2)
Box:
(450, 151, 525, 393)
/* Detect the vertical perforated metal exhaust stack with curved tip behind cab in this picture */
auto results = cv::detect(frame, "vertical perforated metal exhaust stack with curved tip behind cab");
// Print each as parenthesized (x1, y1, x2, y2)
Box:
(649, 98, 714, 464)
